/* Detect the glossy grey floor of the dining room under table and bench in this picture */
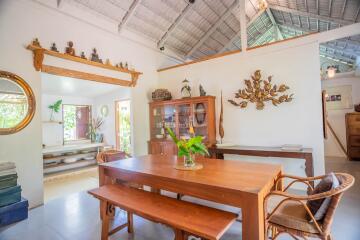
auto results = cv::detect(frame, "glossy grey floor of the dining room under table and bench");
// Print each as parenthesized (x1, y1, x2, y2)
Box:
(0, 158, 360, 240)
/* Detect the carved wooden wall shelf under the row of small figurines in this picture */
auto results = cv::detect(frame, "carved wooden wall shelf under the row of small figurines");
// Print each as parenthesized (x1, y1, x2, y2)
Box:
(27, 44, 142, 87)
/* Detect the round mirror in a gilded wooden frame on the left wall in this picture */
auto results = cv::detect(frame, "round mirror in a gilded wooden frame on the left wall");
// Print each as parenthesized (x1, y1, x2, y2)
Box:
(0, 71, 35, 135)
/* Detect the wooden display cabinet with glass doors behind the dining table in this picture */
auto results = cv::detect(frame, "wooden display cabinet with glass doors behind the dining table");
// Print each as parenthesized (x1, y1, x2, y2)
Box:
(148, 96, 216, 155)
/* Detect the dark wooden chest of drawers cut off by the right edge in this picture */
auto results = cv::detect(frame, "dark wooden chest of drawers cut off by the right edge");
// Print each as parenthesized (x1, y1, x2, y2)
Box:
(345, 112, 360, 160)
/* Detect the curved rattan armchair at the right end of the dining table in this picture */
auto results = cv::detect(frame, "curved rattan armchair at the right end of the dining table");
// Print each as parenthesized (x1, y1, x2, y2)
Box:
(264, 173, 354, 240)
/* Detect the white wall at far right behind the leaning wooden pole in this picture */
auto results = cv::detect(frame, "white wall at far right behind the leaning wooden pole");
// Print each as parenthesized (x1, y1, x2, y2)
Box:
(322, 77, 360, 157)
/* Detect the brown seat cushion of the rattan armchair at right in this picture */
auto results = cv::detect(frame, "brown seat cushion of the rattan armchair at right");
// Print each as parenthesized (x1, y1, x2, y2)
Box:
(268, 196, 319, 234)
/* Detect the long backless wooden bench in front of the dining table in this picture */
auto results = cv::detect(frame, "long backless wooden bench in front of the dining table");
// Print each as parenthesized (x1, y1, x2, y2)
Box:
(89, 185, 237, 240)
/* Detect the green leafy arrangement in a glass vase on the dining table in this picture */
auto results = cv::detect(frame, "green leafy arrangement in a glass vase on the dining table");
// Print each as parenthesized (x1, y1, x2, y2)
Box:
(166, 127, 209, 168)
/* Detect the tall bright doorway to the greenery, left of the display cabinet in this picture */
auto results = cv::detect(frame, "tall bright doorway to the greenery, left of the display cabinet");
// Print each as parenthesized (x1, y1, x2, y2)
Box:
(115, 100, 132, 155)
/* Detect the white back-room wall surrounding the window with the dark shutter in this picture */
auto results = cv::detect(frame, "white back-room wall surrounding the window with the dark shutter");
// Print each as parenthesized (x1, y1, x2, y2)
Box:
(41, 94, 96, 147)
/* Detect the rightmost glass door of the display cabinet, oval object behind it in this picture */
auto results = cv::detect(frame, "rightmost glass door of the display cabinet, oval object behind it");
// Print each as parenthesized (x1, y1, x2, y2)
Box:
(192, 102, 208, 141)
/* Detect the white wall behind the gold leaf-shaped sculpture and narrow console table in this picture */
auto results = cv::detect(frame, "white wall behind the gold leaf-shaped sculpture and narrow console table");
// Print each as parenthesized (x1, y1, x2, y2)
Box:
(159, 42, 324, 176)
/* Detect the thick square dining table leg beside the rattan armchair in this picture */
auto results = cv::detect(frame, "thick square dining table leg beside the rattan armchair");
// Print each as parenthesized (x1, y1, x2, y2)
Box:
(241, 195, 265, 240)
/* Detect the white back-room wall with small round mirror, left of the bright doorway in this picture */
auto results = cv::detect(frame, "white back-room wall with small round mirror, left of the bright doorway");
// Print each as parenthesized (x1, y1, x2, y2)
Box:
(94, 88, 134, 147)
